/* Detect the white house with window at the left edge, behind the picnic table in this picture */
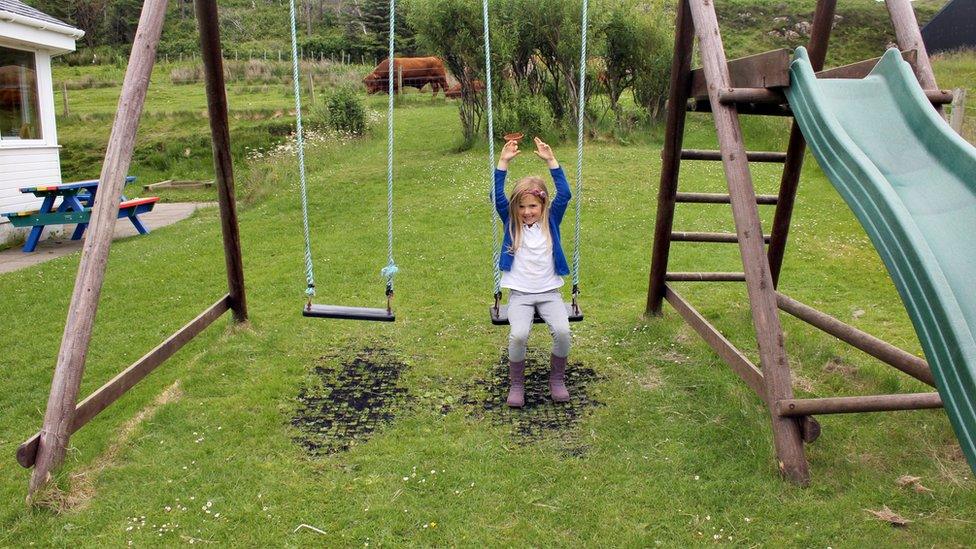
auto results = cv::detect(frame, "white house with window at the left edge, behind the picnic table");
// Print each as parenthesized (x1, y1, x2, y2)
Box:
(0, 0, 85, 242)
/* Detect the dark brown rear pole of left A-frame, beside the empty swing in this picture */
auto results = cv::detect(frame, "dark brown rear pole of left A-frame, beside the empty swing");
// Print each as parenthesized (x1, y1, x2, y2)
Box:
(194, 0, 247, 322)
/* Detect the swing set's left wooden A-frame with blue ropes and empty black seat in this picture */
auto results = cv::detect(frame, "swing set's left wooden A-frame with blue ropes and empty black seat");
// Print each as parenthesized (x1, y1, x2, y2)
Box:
(17, 0, 586, 498)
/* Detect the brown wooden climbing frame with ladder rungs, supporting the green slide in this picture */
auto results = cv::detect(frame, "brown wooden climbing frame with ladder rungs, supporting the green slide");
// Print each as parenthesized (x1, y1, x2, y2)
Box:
(647, 0, 952, 485)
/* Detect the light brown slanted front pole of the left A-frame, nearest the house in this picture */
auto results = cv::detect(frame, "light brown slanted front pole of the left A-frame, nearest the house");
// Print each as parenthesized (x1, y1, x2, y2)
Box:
(29, 0, 166, 494)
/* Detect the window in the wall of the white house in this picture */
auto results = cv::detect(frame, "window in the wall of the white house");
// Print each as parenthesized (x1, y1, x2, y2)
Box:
(0, 47, 41, 141)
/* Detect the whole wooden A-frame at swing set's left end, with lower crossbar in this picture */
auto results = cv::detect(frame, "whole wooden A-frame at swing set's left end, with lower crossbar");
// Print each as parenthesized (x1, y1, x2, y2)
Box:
(24, 0, 247, 495)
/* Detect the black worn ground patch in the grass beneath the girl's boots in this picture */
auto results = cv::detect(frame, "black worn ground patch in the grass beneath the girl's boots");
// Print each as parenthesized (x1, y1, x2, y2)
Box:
(461, 350, 605, 456)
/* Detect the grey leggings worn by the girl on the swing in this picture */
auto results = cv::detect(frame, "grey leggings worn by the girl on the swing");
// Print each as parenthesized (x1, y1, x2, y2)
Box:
(508, 290, 570, 362)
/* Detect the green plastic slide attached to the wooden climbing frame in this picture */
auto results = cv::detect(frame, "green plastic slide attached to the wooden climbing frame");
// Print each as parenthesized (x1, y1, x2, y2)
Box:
(786, 48, 976, 471)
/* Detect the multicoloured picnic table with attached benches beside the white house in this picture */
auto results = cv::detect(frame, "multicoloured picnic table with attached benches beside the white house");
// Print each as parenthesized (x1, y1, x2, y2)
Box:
(0, 175, 159, 253)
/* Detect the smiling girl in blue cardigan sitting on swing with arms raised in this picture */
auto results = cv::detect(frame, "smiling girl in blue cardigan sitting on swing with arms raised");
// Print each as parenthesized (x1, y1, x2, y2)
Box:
(495, 137, 571, 408)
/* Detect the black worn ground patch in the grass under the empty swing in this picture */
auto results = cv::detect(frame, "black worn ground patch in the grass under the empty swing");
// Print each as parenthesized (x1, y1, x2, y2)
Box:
(291, 348, 409, 455)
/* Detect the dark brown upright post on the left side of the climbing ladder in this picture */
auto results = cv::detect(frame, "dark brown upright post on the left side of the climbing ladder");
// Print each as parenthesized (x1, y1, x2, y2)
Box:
(645, 0, 695, 315)
